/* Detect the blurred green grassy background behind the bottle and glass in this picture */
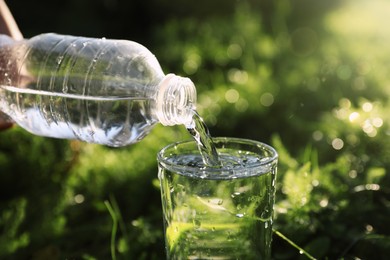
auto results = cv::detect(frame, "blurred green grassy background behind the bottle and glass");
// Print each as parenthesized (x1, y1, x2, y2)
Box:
(0, 0, 390, 259)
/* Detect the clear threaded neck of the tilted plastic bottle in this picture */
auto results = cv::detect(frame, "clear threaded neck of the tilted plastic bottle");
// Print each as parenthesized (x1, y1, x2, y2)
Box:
(156, 74, 196, 126)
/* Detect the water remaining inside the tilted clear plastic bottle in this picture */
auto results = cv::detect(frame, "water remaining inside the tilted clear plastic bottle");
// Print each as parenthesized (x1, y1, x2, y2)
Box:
(0, 86, 155, 147)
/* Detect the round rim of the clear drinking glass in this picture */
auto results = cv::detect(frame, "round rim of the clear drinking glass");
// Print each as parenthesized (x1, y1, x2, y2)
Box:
(157, 137, 278, 177)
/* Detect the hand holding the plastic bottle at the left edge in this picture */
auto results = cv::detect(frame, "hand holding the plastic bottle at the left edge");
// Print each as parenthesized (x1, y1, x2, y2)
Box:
(0, 0, 23, 131)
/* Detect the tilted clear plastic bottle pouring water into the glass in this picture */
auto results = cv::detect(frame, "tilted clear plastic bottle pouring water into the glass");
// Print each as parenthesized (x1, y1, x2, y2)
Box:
(0, 34, 196, 146)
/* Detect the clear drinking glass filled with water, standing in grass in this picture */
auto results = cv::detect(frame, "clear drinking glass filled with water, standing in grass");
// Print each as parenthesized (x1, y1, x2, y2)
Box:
(158, 138, 278, 260)
